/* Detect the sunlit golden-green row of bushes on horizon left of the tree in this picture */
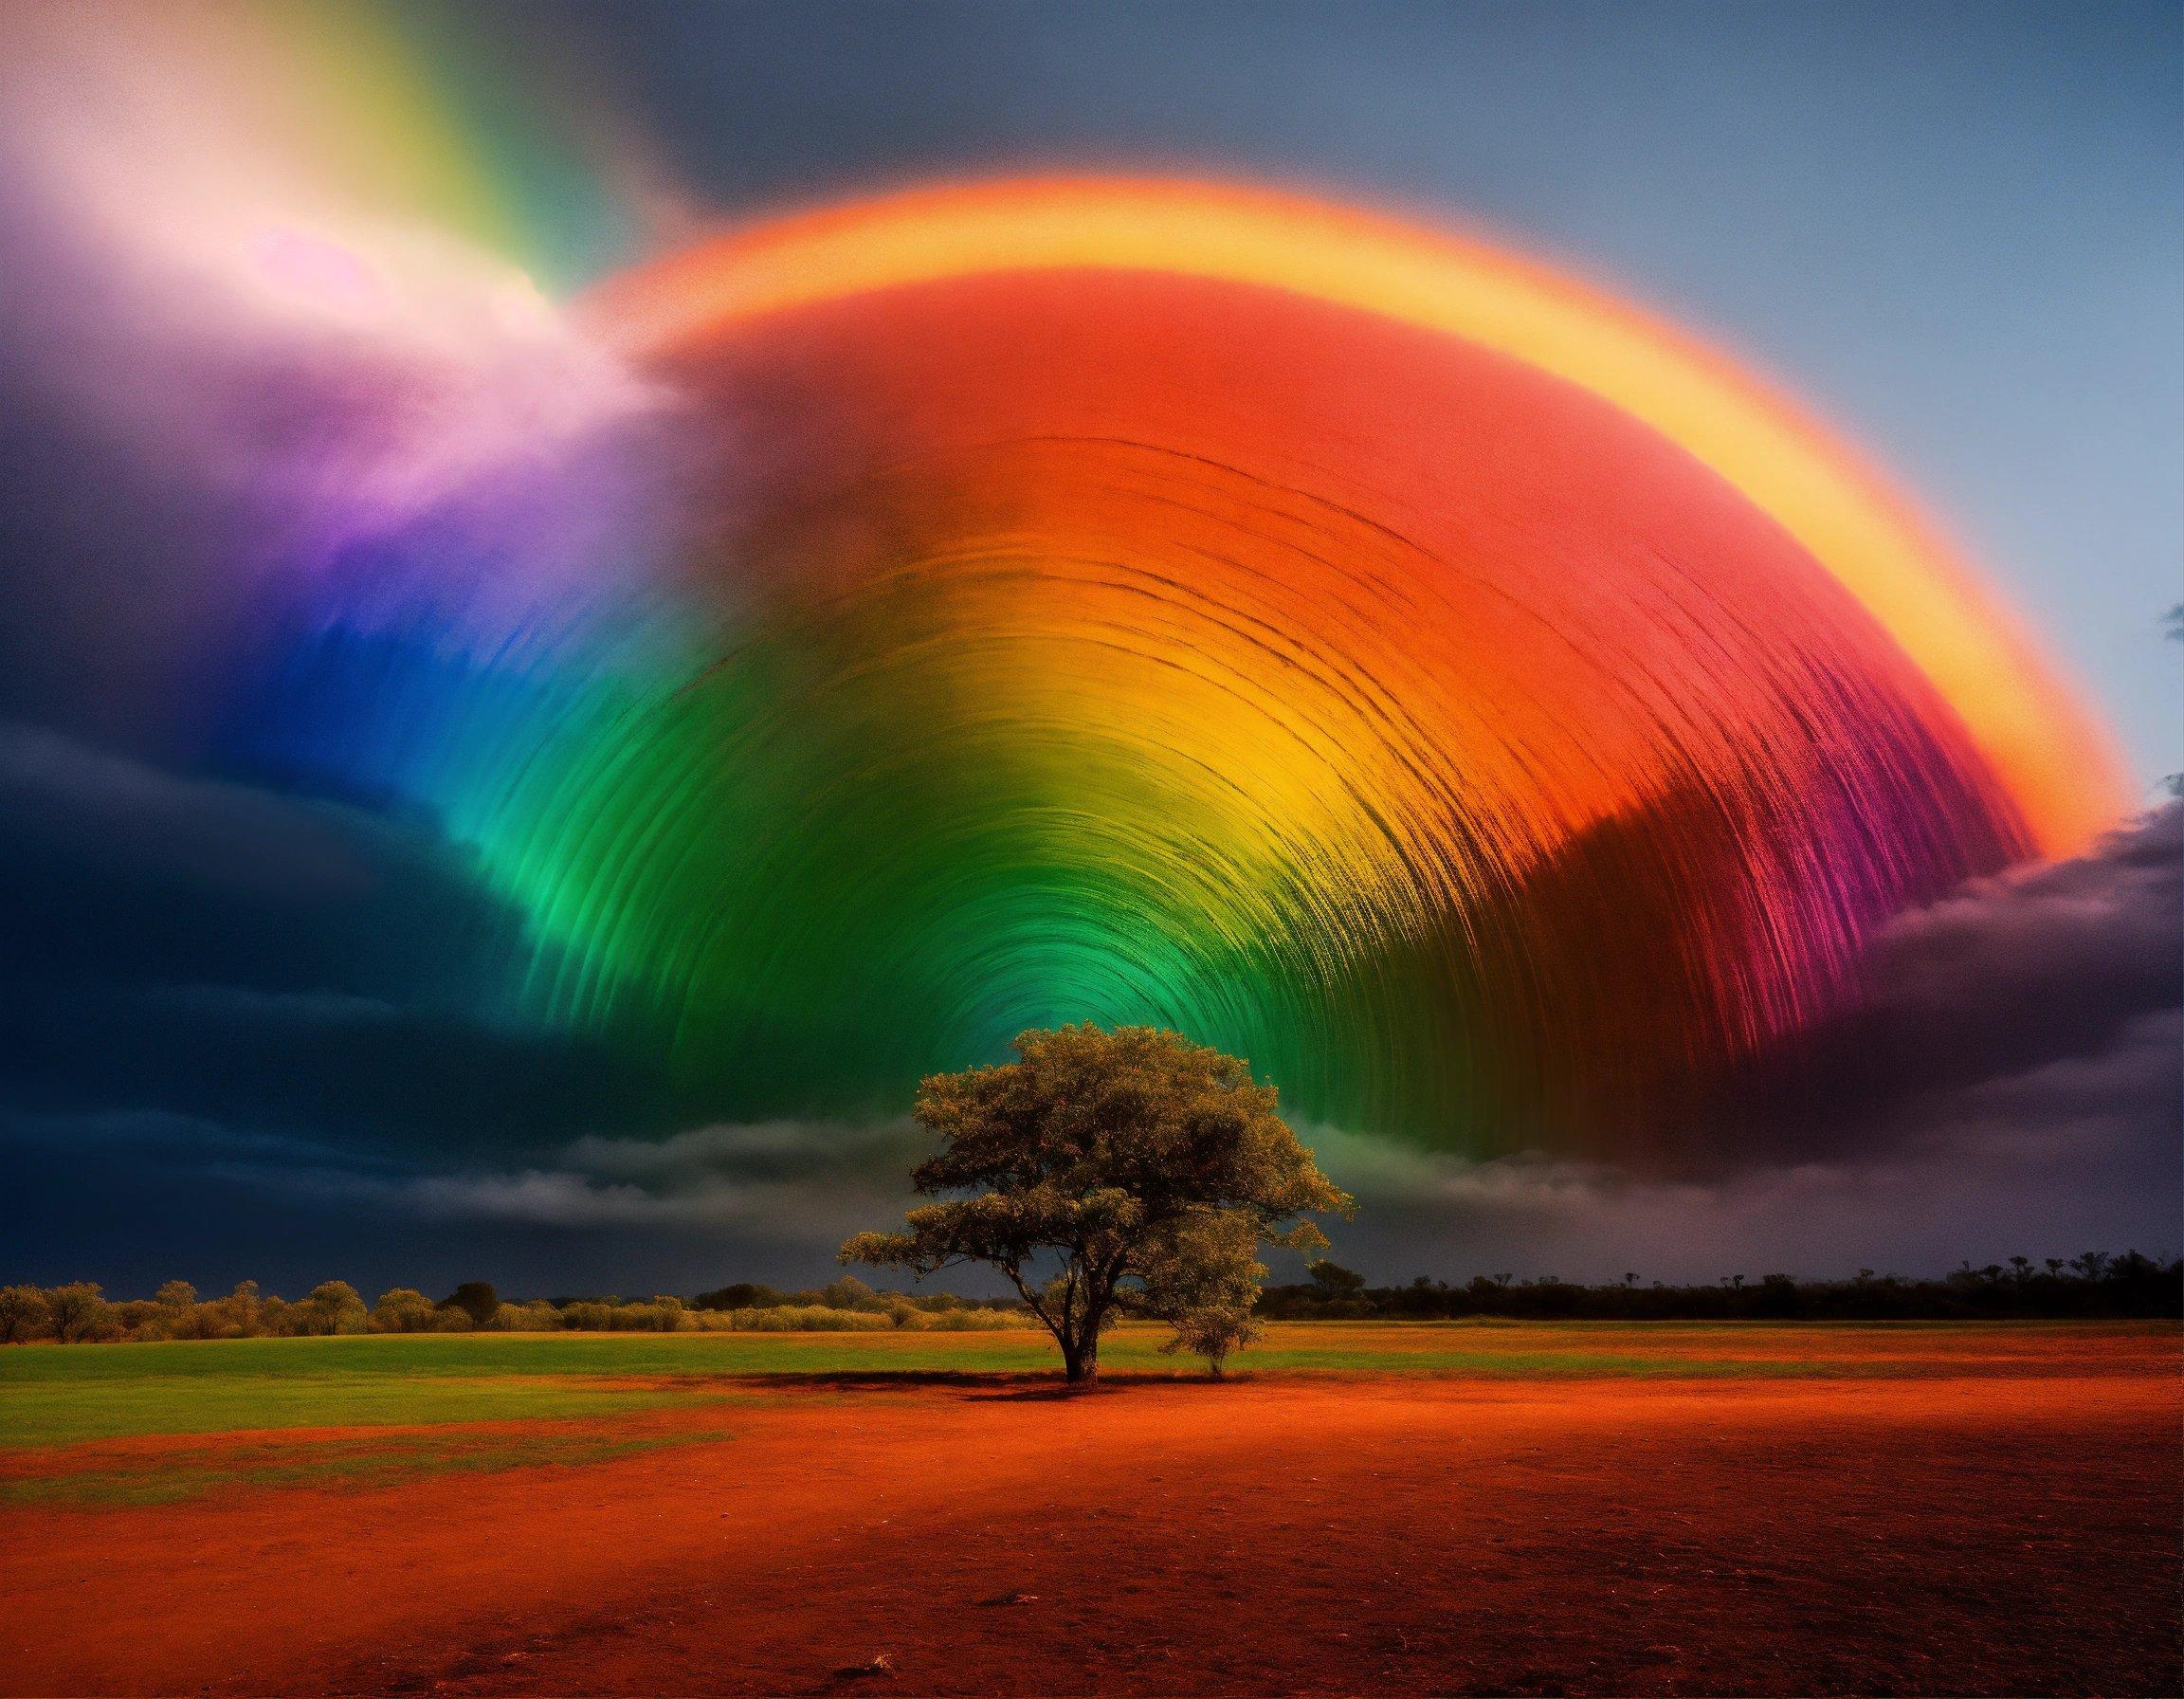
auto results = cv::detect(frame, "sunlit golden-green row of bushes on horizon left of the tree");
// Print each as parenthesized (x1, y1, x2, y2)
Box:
(0, 1277, 1030, 1345)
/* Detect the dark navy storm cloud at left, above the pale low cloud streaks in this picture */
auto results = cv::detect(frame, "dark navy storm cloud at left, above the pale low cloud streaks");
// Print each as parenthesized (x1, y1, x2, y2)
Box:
(0, 725, 655, 1151)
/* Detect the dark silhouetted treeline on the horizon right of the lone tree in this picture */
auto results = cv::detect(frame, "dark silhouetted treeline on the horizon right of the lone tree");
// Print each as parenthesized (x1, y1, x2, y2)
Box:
(1258, 1251, 2184, 1322)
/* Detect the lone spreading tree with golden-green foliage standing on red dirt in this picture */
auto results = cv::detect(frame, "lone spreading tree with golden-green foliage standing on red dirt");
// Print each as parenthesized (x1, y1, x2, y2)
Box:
(841, 1022, 1354, 1384)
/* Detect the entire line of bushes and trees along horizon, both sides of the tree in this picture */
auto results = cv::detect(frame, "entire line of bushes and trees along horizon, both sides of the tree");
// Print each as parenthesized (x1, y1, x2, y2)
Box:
(0, 1251, 2184, 1343)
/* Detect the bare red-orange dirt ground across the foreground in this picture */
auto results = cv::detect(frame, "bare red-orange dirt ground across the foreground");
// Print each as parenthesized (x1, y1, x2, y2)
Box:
(0, 1341, 2184, 1694)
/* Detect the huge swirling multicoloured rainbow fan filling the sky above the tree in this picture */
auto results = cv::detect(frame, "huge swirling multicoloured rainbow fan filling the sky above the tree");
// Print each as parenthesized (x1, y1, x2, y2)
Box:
(200, 179, 2122, 1160)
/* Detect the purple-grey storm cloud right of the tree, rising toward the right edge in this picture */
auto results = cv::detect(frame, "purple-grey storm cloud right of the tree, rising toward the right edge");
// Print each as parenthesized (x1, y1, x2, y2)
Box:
(1283, 804, 2184, 1280)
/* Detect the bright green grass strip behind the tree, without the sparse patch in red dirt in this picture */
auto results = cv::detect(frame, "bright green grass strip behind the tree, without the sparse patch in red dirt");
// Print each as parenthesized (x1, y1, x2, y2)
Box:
(0, 1322, 2149, 1450)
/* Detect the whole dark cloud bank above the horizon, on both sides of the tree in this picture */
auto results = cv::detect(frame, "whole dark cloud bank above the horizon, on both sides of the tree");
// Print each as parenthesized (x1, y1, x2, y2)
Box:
(0, 681, 2184, 1290)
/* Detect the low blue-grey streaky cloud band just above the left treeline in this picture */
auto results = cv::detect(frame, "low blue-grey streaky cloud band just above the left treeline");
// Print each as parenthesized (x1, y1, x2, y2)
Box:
(0, 1111, 947, 1293)
